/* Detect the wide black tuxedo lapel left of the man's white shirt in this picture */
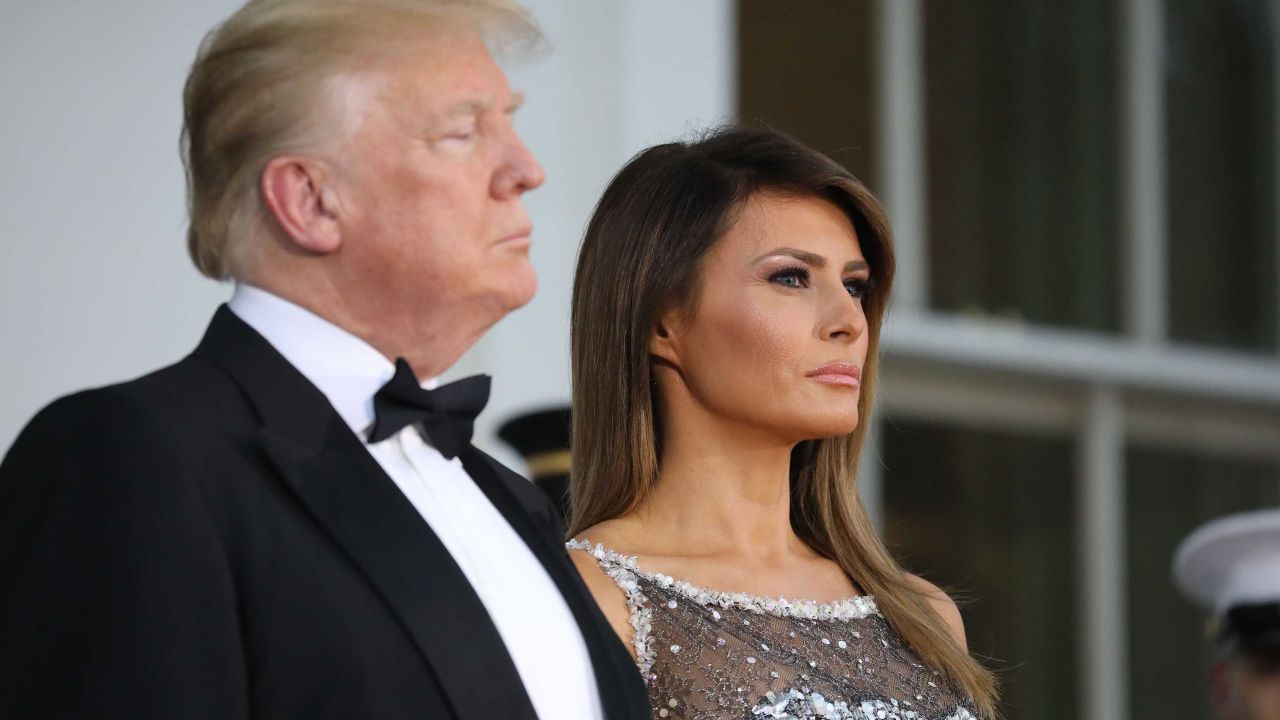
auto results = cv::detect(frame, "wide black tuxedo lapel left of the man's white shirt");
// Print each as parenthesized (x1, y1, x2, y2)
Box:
(196, 307, 536, 720)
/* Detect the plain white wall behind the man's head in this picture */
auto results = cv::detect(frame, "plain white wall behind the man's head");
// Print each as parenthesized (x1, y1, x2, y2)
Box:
(0, 0, 733, 466)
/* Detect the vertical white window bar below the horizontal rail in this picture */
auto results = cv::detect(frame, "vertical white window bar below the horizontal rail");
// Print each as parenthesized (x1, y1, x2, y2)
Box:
(1076, 386, 1129, 720)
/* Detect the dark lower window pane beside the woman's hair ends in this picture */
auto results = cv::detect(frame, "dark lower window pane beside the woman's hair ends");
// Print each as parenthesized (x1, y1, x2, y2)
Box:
(881, 421, 1079, 720)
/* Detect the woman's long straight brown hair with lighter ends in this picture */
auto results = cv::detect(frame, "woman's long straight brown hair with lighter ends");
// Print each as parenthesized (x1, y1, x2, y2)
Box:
(570, 128, 996, 717)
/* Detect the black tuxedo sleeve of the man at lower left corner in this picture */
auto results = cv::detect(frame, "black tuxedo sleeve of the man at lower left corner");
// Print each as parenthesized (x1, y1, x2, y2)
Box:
(0, 389, 248, 720)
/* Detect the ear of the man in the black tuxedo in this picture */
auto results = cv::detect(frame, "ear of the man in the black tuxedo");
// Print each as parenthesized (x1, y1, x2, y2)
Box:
(261, 155, 342, 255)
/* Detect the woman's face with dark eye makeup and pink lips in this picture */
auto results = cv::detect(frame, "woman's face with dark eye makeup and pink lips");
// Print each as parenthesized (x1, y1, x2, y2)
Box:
(653, 193, 870, 442)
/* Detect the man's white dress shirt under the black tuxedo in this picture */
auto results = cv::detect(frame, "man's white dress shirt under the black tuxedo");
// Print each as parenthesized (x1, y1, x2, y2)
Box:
(229, 284, 604, 720)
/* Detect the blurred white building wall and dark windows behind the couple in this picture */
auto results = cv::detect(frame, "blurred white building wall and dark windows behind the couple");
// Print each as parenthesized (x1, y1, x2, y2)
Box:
(0, 0, 1280, 720)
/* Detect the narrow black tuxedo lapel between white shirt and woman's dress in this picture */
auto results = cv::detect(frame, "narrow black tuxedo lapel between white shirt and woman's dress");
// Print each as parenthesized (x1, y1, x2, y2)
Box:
(460, 446, 649, 720)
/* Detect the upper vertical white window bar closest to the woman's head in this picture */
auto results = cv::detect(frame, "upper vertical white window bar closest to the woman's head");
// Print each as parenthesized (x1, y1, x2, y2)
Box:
(872, 0, 929, 313)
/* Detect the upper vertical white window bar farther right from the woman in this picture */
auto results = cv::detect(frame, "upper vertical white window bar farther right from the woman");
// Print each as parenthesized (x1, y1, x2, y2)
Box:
(1123, 0, 1169, 345)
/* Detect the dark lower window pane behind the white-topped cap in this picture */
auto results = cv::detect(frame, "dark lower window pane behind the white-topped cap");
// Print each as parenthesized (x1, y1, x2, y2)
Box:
(1126, 447, 1280, 717)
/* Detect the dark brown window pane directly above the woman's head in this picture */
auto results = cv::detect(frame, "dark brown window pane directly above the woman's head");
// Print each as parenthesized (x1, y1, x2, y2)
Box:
(737, 0, 874, 184)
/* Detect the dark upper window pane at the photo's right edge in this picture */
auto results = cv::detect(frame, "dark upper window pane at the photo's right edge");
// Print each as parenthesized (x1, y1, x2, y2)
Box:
(1165, 0, 1277, 350)
